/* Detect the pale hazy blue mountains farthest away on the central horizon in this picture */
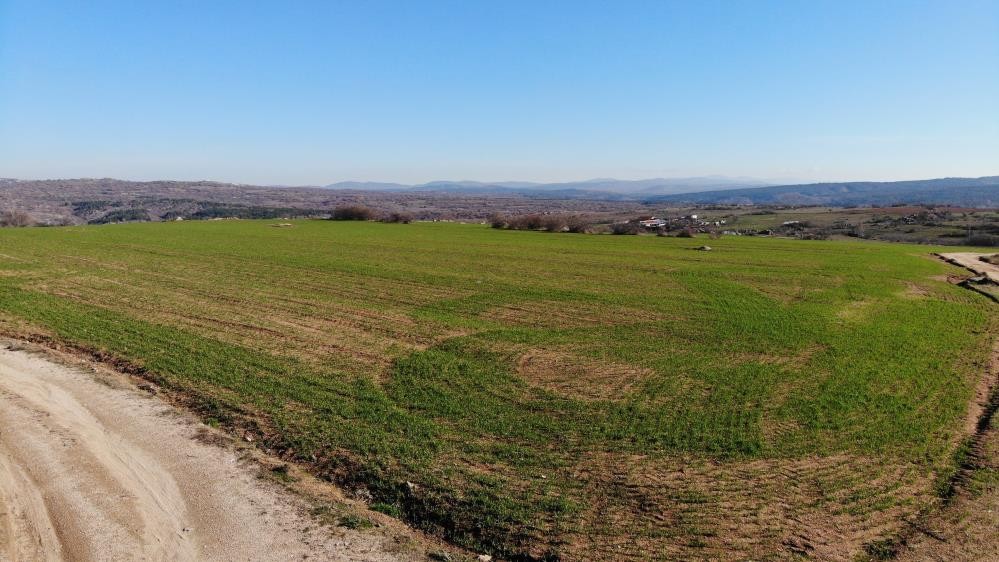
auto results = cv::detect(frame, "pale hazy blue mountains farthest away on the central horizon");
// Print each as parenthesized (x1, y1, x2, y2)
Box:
(324, 176, 775, 199)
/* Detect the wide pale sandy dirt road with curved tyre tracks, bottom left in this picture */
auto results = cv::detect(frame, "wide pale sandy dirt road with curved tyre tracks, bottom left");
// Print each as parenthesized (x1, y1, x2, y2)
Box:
(0, 347, 416, 562)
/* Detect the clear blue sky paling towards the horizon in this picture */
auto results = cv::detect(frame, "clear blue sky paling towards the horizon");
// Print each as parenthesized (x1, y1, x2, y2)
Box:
(0, 0, 999, 184)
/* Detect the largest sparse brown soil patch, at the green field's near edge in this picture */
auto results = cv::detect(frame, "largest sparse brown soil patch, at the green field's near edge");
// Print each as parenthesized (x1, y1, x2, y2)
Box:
(567, 455, 935, 561)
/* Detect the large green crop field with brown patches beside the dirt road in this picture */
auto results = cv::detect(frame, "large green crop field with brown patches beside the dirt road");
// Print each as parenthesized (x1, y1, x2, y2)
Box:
(0, 220, 999, 560)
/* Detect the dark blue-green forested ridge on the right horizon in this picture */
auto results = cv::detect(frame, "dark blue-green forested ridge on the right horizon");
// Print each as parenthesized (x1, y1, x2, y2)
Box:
(643, 176, 999, 207)
